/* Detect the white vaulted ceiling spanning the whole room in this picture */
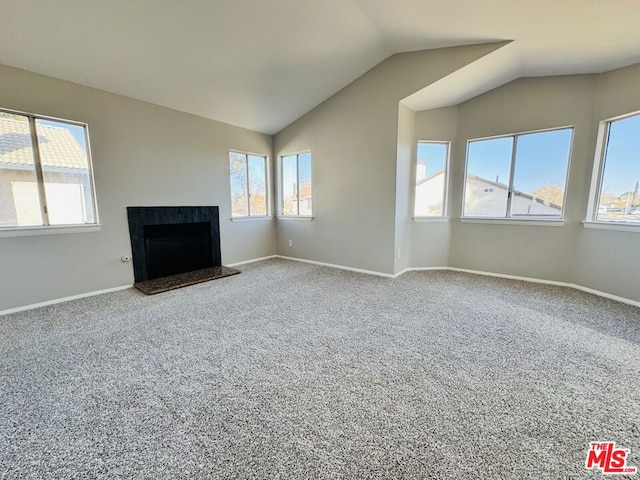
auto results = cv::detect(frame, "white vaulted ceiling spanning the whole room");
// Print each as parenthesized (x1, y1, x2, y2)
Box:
(0, 0, 640, 134)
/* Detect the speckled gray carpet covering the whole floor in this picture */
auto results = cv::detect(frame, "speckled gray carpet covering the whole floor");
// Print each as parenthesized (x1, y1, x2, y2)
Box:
(0, 260, 640, 479)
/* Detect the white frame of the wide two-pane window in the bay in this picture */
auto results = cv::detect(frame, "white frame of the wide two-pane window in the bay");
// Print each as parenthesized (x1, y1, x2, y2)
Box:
(460, 125, 575, 220)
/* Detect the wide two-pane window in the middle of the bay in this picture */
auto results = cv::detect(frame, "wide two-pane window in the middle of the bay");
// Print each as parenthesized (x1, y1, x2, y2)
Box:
(463, 128, 573, 219)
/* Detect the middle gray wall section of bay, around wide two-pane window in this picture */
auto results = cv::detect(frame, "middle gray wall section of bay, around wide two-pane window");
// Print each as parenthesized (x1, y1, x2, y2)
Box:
(451, 75, 596, 282)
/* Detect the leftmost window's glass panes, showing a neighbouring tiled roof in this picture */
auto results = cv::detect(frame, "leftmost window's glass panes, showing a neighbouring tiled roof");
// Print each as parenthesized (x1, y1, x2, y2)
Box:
(0, 110, 97, 229)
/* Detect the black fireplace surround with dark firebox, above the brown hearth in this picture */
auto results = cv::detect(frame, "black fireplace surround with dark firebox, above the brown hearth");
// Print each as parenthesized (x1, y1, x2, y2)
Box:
(127, 206, 222, 283)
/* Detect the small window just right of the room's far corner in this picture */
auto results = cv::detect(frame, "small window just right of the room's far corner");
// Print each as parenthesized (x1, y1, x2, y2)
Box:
(281, 152, 312, 216)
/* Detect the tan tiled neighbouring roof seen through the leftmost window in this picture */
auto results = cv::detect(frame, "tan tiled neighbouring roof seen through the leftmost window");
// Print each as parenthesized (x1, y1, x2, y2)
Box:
(0, 118, 88, 169)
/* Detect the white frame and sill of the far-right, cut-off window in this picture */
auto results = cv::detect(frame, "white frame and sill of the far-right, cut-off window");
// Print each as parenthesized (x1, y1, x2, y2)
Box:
(583, 110, 640, 232)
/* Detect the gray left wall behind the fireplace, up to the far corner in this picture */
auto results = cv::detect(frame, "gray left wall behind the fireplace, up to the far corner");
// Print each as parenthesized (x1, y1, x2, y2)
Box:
(0, 66, 275, 310)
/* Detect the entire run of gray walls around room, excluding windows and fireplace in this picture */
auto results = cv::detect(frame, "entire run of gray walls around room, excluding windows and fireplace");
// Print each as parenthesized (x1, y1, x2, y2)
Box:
(0, 53, 640, 310)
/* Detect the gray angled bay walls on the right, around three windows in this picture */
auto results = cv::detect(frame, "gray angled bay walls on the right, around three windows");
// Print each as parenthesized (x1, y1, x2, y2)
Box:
(411, 65, 640, 301)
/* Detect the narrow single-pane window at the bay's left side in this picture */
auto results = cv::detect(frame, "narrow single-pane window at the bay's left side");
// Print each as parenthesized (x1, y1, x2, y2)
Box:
(414, 142, 449, 217)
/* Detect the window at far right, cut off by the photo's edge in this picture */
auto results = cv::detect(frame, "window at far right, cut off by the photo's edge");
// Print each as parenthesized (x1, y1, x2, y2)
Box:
(591, 113, 640, 224)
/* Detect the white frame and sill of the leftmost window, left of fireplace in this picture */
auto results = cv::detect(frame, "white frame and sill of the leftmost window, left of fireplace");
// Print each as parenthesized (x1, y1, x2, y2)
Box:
(0, 107, 102, 238)
